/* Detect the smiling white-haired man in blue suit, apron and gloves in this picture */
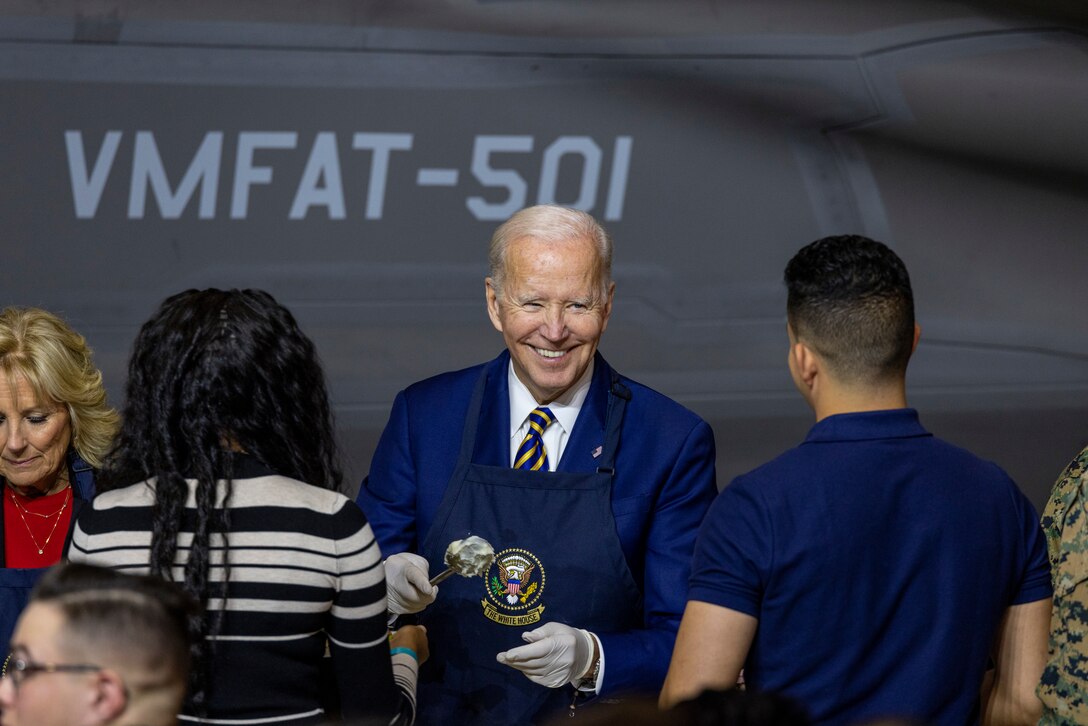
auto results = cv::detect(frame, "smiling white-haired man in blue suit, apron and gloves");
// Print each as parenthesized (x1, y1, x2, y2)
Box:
(359, 206, 716, 724)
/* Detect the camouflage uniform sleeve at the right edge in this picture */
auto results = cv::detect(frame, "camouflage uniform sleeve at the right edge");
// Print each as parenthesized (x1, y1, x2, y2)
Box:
(1037, 447, 1088, 724)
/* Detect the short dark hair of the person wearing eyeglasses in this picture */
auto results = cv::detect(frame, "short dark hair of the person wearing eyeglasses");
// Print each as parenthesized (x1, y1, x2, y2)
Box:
(30, 563, 199, 692)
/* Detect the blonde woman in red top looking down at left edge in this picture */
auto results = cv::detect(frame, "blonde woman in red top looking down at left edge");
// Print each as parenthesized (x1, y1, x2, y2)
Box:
(0, 307, 119, 642)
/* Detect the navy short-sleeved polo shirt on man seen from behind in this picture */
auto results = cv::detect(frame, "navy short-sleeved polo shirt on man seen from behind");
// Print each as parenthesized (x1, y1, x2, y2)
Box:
(688, 408, 1051, 725)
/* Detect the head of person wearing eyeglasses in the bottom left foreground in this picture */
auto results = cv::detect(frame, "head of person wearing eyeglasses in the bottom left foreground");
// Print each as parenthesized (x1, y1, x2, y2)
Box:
(0, 564, 195, 726)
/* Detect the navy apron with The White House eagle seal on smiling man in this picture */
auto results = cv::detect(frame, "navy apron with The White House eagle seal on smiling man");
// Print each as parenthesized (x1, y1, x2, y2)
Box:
(417, 369, 642, 726)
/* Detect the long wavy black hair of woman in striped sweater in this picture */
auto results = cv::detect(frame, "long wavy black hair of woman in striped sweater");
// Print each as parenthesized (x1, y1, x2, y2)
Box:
(99, 290, 342, 714)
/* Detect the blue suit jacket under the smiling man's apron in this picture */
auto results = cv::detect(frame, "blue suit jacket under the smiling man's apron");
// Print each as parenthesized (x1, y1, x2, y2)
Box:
(358, 352, 717, 694)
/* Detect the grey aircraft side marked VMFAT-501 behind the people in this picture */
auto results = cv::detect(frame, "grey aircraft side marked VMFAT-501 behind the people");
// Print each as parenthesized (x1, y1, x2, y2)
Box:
(0, 0, 1088, 507)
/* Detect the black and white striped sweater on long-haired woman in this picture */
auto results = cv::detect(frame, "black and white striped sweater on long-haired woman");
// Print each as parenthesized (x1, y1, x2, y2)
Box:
(69, 465, 418, 725)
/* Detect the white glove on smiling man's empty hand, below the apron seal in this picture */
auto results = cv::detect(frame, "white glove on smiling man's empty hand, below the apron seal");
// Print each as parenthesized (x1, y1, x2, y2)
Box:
(495, 623, 593, 688)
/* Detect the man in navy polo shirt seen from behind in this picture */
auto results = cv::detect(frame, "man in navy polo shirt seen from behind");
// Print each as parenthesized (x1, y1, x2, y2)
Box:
(662, 236, 1051, 725)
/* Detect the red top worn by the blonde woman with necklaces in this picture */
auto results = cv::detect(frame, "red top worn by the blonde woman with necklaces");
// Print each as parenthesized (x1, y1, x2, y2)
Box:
(3, 485, 72, 567)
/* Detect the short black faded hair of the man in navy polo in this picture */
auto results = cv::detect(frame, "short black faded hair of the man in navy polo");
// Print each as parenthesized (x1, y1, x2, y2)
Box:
(784, 235, 914, 384)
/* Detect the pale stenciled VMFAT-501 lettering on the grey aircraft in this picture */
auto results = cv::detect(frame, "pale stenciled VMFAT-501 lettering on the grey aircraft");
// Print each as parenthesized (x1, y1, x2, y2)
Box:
(64, 130, 633, 222)
